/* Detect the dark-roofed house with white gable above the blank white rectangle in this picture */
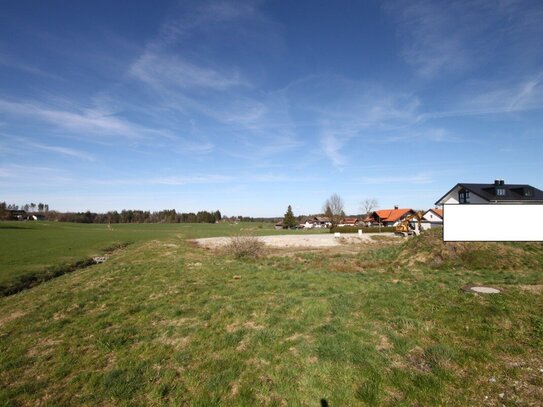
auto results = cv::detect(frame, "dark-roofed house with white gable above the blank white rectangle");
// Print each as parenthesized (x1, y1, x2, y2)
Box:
(436, 179, 543, 205)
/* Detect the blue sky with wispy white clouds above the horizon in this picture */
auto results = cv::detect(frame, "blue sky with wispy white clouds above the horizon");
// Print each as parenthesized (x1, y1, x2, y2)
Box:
(0, 0, 543, 216)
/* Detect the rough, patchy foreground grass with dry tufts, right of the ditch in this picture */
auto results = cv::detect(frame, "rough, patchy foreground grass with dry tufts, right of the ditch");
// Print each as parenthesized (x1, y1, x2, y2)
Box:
(0, 225, 543, 406)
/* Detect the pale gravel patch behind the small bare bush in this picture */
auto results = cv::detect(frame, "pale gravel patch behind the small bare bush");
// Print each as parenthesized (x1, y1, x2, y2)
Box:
(194, 233, 394, 248)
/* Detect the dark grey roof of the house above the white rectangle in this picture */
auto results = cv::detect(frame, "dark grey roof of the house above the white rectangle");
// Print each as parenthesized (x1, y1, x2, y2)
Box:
(436, 182, 543, 205)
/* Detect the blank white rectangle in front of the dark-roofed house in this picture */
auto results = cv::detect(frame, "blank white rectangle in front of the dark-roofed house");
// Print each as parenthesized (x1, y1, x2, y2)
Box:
(443, 204, 543, 241)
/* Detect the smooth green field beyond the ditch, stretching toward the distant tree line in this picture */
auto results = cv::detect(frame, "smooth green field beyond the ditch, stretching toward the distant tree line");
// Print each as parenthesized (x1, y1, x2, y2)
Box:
(0, 222, 324, 294)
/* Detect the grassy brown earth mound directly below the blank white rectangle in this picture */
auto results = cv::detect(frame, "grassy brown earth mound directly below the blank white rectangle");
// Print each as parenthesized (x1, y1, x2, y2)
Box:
(397, 230, 543, 270)
